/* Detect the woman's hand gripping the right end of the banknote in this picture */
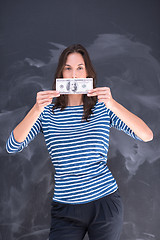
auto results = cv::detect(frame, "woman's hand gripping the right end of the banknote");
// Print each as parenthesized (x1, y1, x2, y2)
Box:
(87, 87, 113, 108)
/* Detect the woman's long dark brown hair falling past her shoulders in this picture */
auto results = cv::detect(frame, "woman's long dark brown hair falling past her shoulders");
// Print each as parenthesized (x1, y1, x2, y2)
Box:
(52, 44, 97, 121)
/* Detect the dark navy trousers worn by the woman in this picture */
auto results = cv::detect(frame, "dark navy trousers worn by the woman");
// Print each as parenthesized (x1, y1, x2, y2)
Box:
(49, 190, 123, 240)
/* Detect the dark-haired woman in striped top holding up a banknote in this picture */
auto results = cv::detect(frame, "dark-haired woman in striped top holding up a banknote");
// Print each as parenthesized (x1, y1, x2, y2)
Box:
(6, 44, 153, 240)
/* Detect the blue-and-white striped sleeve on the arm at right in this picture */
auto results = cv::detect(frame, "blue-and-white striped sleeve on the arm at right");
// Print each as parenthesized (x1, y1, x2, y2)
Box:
(108, 109, 143, 141)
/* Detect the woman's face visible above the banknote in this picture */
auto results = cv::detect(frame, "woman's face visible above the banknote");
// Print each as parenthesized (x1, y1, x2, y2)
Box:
(62, 53, 87, 78)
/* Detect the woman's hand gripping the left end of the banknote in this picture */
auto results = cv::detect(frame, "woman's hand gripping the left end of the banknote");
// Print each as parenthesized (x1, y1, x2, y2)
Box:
(35, 90, 60, 112)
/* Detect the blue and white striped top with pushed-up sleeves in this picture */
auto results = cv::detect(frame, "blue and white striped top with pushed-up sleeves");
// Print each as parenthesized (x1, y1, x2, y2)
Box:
(6, 102, 141, 204)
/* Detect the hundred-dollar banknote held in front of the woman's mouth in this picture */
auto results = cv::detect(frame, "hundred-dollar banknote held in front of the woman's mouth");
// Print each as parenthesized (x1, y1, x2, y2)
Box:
(56, 78, 93, 94)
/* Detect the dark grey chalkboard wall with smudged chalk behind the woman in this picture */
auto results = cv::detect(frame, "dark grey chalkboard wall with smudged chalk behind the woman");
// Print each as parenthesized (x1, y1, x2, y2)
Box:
(0, 0, 160, 240)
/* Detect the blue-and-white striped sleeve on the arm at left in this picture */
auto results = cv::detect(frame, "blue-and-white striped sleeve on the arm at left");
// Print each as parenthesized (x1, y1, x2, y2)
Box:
(6, 113, 42, 153)
